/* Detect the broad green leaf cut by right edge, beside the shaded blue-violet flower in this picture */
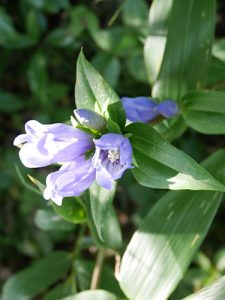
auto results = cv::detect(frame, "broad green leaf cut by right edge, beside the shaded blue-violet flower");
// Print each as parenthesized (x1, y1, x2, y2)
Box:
(183, 91, 225, 134)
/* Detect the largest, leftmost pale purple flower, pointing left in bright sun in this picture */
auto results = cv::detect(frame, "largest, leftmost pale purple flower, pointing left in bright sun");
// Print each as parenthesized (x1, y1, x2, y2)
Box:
(14, 120, 93, 168)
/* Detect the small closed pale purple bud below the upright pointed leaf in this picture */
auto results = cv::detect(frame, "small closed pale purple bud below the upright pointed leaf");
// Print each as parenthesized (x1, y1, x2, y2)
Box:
(74, 108, 106, 131)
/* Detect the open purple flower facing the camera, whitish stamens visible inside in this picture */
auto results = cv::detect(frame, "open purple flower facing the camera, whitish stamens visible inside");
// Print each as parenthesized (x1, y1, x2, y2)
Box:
(92, 133, 132, 190)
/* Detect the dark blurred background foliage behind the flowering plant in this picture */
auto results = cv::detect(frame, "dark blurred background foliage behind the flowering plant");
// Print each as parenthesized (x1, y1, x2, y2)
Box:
(0, 0, 225, 300)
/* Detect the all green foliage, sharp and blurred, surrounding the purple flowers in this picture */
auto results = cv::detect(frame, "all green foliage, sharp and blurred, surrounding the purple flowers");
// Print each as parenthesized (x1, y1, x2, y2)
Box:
(0, 0, 225, 300)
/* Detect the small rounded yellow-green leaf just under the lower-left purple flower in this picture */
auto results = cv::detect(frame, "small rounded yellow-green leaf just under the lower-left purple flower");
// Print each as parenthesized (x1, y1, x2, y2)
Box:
(51, 197, 87, 224)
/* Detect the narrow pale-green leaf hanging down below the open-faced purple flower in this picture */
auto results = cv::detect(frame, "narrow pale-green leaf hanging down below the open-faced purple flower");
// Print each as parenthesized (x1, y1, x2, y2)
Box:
(86, 183, 122, 249)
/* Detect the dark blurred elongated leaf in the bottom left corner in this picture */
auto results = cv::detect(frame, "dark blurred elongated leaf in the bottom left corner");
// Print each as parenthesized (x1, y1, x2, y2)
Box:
(1, 252, 71, 300)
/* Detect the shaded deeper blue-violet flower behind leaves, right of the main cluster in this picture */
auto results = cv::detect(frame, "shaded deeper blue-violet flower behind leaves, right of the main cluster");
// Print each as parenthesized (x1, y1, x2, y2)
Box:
(121, 97, 178, 123)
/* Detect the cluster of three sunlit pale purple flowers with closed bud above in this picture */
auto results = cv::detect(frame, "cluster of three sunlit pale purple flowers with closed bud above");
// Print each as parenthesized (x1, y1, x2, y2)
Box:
(14, 111, 132, 205)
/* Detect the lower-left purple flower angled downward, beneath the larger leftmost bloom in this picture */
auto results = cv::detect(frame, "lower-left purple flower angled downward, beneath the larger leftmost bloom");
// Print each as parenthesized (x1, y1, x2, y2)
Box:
(44, 156, 95, 205)
